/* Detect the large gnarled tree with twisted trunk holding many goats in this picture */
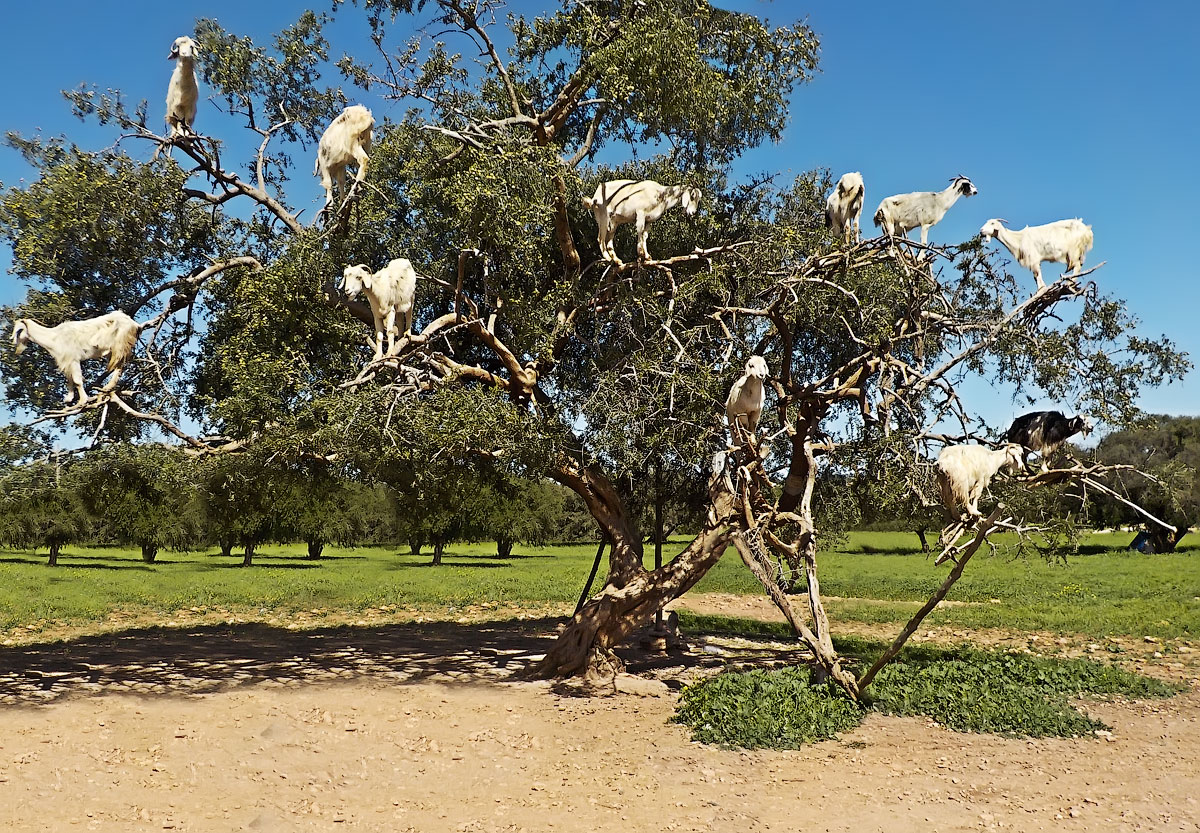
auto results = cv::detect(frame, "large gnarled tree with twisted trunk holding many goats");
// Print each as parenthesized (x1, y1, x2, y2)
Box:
(0, 0, 1187, 695)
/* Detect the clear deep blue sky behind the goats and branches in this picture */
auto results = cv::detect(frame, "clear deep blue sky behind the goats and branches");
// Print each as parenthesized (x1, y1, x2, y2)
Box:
(0, 0, 1200, 423)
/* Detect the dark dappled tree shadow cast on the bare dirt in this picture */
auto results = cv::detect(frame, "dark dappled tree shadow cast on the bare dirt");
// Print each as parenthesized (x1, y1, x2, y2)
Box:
(0, 618, 806, 708)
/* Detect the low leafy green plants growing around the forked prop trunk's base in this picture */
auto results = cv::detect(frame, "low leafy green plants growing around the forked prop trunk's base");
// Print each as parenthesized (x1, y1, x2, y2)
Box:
(673, 641, 1182, 749)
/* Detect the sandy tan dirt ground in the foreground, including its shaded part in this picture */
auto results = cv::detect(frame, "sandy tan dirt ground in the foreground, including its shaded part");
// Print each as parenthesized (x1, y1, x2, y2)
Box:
(0, 597, 1200, 833)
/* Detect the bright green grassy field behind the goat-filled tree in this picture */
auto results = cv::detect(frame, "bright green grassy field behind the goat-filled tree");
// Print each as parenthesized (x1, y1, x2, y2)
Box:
(0, 533, 1200, 637)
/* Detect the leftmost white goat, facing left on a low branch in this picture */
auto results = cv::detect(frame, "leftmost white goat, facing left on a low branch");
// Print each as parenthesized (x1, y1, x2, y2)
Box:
(12, 310, 140, 404)
